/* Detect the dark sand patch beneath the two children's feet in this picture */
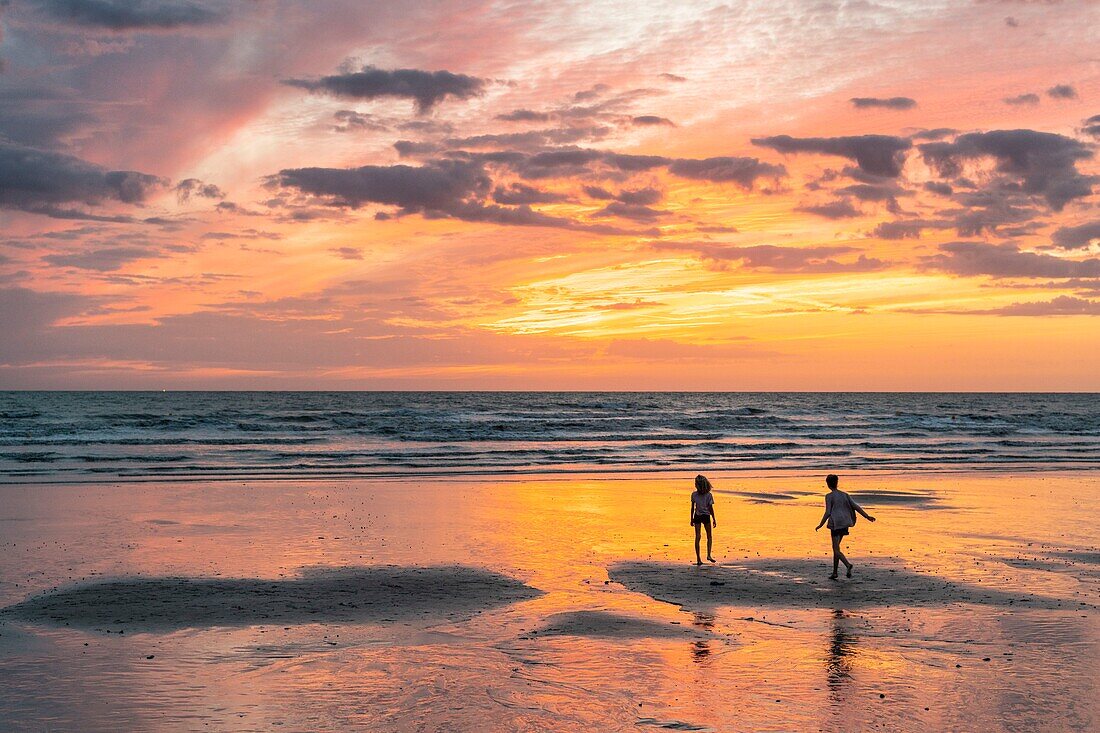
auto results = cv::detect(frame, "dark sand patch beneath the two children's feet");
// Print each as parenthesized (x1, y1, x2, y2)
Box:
(607, 559, 1082, 610)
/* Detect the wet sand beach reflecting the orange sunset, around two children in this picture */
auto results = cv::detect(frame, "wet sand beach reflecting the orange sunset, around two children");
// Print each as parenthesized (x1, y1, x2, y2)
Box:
(0, 473, 1100, 731)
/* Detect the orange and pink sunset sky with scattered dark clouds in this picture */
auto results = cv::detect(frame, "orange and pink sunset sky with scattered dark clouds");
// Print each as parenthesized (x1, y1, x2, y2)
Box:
(0, 0, 1100, 391)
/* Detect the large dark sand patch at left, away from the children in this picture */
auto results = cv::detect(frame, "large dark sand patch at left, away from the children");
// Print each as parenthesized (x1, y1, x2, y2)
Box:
(0, 566, 540, 631)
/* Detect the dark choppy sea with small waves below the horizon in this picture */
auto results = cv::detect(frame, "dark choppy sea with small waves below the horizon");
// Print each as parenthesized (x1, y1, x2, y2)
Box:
(0, 392, 1100, 483)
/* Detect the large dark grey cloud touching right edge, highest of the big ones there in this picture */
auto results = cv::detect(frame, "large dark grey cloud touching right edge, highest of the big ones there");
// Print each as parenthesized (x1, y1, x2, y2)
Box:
(919, 130, 1100, 211)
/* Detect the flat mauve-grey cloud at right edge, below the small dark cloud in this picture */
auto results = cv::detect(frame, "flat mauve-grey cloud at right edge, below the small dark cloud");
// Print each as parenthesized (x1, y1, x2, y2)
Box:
(922, 242, 1100, 277)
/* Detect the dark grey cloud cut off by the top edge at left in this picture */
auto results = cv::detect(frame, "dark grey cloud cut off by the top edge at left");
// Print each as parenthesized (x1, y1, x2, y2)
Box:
(32, 0, 230, 31)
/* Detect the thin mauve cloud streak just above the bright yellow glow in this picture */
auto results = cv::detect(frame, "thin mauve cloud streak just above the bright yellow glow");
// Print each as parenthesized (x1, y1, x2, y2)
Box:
(650, 242, 889, 273)
